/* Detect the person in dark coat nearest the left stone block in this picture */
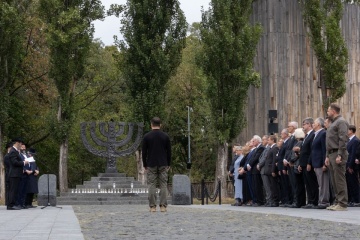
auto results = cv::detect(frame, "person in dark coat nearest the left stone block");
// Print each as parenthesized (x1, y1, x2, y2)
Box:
(25, 148, 39, 208)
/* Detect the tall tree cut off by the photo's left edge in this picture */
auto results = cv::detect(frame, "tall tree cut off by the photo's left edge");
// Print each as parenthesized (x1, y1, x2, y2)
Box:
(0, 0, 32, 199)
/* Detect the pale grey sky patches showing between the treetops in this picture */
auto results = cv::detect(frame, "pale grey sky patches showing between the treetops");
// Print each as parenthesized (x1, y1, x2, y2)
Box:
(94, 0, 210, 45)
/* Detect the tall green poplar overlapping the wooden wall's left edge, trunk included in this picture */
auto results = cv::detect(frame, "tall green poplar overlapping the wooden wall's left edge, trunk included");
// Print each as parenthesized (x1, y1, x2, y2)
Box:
(199, 0, 262, 196)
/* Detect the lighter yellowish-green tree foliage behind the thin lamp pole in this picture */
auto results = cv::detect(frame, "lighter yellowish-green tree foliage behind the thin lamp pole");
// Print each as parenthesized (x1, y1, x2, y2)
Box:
(164, 23, 216, 182)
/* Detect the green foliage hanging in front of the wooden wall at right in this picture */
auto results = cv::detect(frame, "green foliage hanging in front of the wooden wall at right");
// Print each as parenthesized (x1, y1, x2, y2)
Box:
(300, 0, 349, 109)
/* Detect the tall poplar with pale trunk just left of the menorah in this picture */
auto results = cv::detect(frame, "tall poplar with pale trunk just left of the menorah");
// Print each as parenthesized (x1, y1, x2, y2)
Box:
(39, 0, 104, 192)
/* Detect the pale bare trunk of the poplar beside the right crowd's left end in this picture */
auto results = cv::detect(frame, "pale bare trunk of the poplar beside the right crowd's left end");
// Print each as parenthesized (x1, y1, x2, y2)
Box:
(215, 142, 228, 198)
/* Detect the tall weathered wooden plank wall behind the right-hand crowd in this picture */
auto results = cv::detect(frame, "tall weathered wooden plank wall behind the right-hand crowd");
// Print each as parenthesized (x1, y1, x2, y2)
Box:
(237, 0, 360, 144)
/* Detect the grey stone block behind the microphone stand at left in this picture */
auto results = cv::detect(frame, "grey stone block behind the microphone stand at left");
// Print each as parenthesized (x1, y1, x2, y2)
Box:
(38, 174, 56, 206)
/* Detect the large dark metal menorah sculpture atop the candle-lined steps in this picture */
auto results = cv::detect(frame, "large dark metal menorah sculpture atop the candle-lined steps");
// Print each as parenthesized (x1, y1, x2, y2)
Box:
(81, 122, 144, 173)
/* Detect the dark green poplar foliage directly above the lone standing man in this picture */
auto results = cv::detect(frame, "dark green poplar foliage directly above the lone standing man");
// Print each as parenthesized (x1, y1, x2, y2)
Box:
(112, 0, 187, 130)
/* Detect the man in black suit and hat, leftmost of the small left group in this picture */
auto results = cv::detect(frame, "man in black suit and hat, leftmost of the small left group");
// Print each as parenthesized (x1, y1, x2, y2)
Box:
(7, 138, 29, 210)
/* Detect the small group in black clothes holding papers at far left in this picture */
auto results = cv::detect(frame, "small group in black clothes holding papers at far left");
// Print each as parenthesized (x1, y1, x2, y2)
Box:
(4, 138, 39, 210)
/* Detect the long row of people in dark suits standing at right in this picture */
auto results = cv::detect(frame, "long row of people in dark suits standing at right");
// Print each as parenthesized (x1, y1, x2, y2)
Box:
(229, 103, 360, 211)
